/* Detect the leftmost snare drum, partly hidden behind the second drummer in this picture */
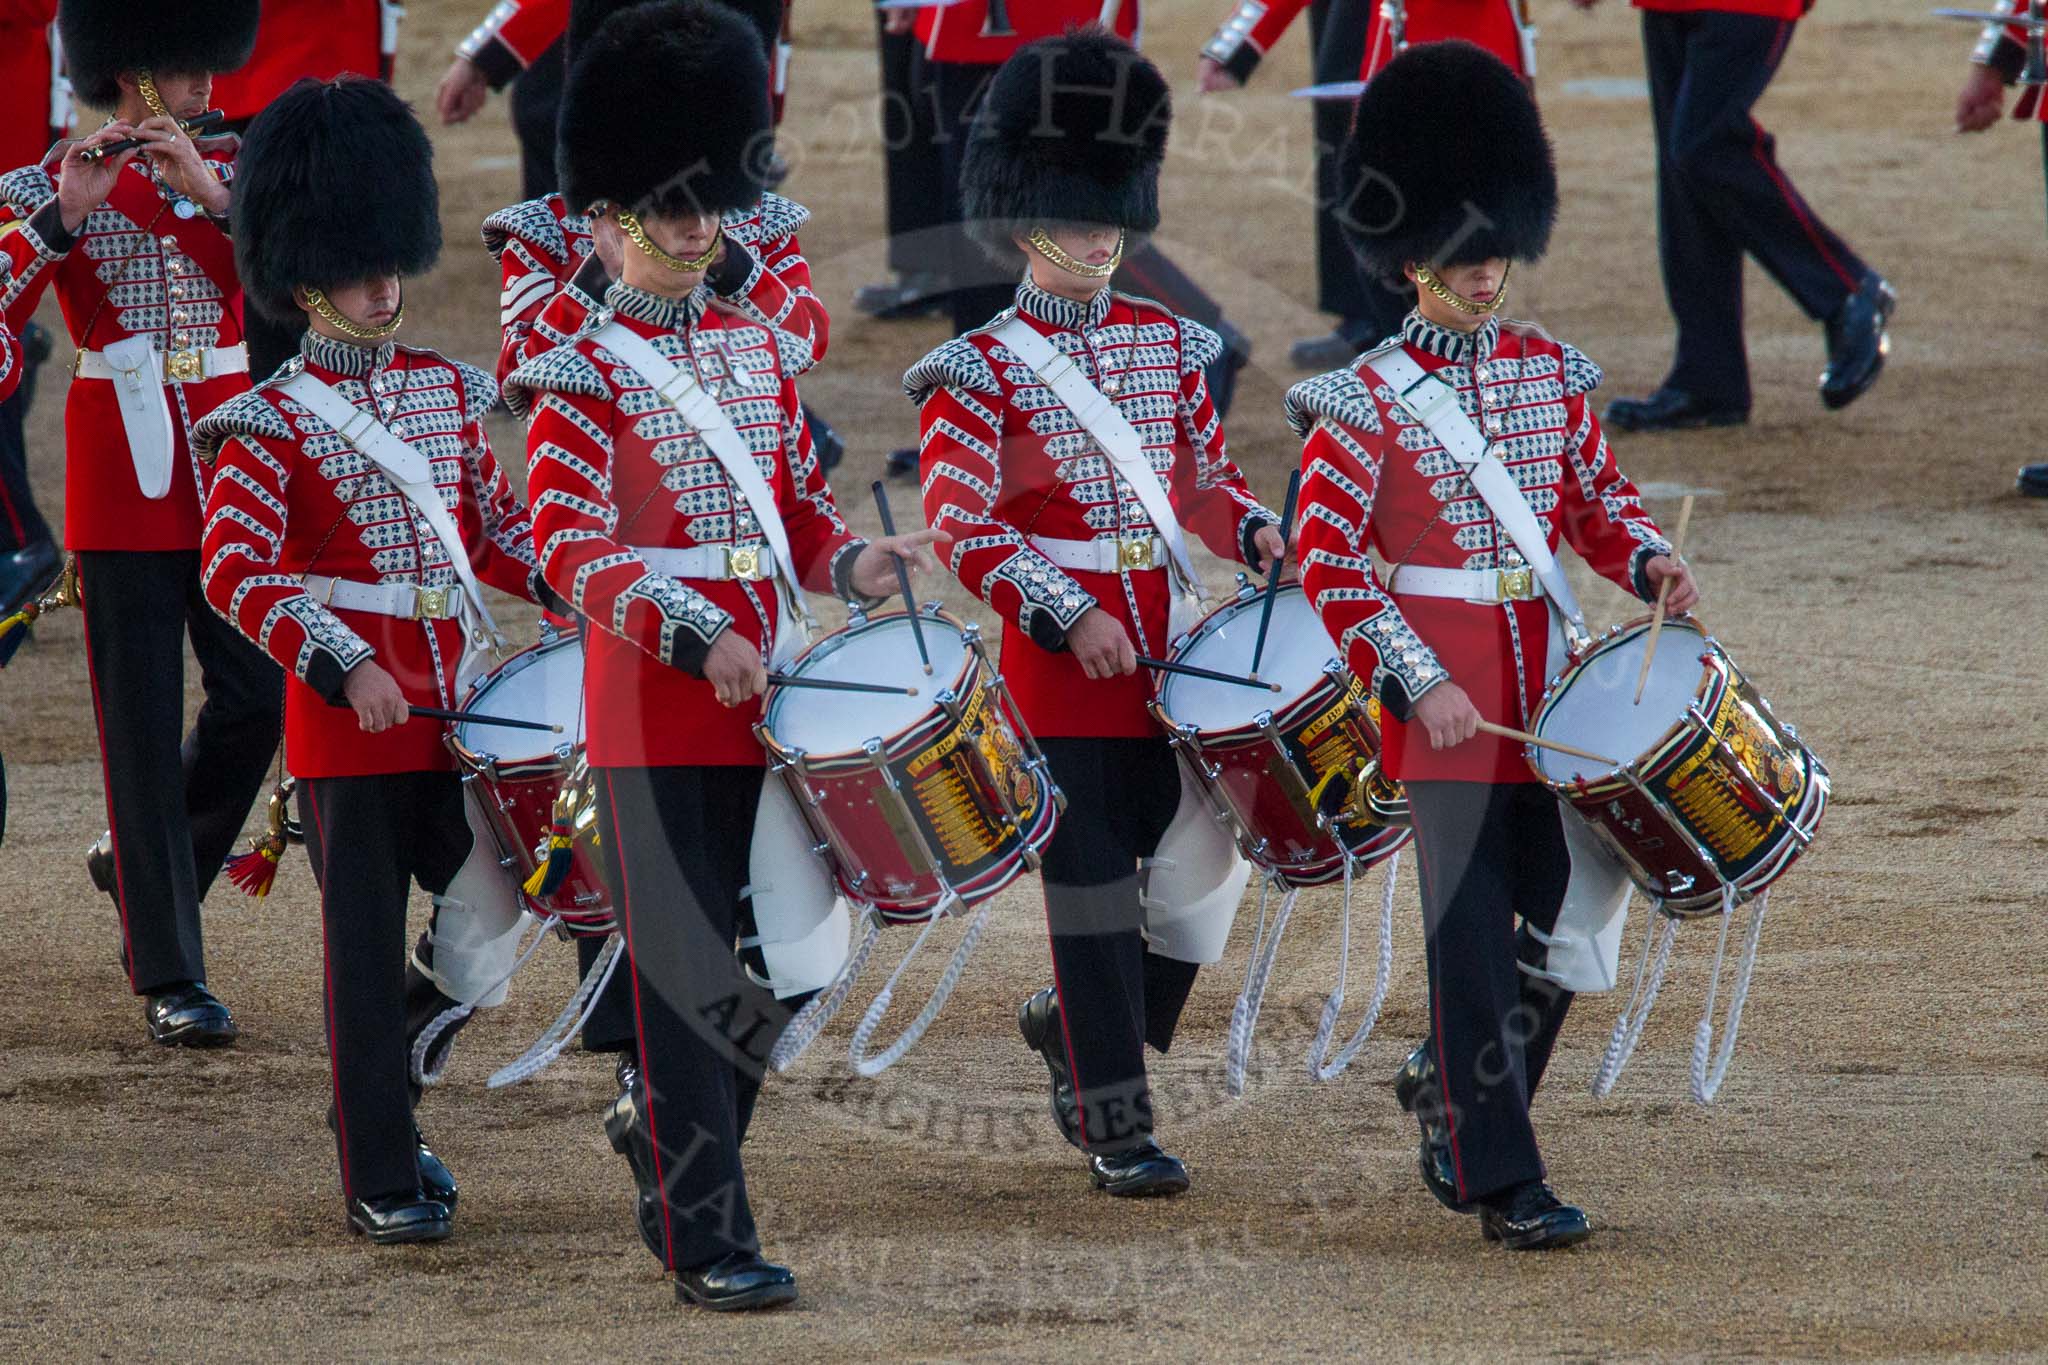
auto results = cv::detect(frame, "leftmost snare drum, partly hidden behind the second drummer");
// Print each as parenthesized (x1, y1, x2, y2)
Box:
(449, 630, 614, 935)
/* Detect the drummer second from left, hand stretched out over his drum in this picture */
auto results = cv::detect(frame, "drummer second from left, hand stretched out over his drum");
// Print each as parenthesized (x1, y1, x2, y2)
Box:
(506, 0, 938, 1310)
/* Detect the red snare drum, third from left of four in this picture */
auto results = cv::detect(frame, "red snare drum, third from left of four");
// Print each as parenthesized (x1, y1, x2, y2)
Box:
(1151, 583, 1409, 886)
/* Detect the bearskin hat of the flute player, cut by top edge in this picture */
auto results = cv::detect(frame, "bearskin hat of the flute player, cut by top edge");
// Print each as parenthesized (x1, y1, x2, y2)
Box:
(57, 0, 262, 108)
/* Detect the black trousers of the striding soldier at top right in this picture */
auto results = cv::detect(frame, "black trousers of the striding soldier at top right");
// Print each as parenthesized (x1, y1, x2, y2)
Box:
(1642, 10, 1870, 411)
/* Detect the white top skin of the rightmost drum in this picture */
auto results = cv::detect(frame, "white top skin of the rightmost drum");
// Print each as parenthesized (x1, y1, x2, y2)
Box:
(1536, 622, 1704, 784)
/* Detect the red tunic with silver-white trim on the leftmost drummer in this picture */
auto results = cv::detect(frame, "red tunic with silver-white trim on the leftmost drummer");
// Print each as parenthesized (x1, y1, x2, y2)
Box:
(195, 334, 535, 778)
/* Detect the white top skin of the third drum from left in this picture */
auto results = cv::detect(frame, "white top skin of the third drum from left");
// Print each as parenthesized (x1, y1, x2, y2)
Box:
(1159, 585, 1337, 731)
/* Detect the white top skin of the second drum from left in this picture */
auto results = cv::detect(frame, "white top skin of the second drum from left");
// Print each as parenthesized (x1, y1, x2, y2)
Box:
(766, 616, 967, 753)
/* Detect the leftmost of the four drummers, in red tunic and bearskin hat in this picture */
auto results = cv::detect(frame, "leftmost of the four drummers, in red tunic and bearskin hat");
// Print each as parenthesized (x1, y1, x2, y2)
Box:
(195, 76, 552, 1242)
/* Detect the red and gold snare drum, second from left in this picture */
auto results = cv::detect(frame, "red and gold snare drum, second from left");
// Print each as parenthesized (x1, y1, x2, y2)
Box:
(756, 604, 1063, 921)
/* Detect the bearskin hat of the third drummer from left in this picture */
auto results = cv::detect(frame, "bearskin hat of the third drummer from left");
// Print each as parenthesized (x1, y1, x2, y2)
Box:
(961, 27, 1174, 264)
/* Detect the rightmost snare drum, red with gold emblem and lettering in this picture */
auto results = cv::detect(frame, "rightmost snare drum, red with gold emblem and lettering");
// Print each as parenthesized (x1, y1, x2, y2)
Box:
(1526, 618, 1829, 915)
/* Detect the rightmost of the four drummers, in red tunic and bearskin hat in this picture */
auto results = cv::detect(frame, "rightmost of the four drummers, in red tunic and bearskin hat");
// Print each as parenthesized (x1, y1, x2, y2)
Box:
(1288, 43, 1698, 1248)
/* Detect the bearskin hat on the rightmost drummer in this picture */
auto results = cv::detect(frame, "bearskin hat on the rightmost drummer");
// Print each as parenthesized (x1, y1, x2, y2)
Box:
(1337, 41, 1556, 280)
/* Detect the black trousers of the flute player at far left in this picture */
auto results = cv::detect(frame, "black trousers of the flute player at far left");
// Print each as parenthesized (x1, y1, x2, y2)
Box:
(78, 551, 285, 995)
